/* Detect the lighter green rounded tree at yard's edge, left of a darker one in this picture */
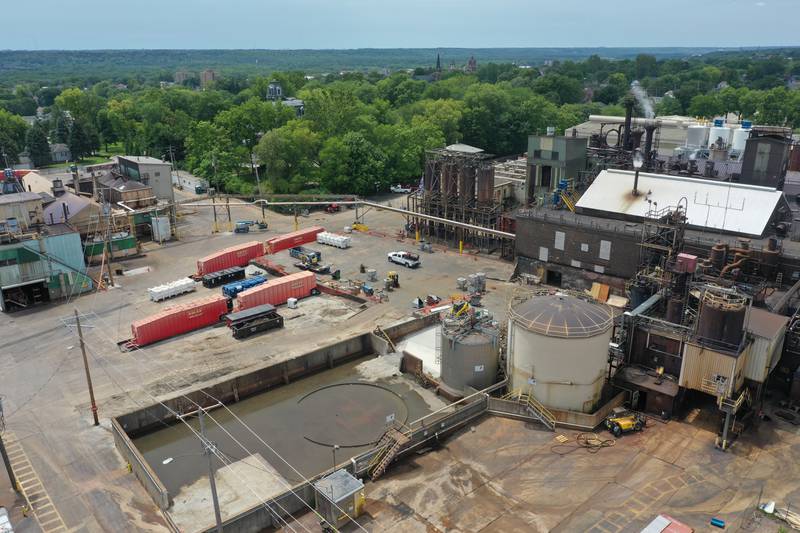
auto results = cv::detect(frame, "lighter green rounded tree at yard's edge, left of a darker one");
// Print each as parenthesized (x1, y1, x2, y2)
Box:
(255, 120, 322, 192)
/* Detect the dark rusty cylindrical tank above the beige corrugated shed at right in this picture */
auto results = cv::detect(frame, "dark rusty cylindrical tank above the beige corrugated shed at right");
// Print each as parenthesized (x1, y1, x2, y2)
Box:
(697, 289, 747, 348)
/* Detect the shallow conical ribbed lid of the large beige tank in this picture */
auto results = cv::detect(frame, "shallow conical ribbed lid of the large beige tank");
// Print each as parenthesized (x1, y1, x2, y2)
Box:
(509, 294, 614, 338)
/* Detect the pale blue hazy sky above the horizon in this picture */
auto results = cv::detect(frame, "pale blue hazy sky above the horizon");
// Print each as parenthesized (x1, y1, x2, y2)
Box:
(0, 0, 800, 50)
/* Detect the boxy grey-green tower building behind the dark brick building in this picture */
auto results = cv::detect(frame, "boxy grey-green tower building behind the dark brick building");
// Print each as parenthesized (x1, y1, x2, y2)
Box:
(525, 135, 586, 204)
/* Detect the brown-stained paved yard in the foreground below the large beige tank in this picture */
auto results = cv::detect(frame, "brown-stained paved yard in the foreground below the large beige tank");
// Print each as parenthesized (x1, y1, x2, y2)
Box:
(284, 406, 800, 533)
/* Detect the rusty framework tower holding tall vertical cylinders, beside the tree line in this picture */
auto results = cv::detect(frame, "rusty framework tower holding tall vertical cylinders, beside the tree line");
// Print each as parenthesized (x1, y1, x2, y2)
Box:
(407, 147, 502, 250)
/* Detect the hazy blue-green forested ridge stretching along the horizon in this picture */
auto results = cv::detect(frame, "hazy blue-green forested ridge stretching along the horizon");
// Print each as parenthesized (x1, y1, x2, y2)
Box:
(0, 47, 714, 86)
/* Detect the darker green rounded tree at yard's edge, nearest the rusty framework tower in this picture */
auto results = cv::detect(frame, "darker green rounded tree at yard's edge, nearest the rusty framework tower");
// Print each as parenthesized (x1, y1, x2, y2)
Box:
(319, 131, 389, 194)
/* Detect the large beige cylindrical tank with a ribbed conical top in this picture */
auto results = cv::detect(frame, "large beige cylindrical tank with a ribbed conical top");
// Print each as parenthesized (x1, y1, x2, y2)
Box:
(508, 293, 614, 413)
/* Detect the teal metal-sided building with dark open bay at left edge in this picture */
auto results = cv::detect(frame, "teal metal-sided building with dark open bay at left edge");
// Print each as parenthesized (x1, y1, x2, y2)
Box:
(0, 224, 94, 312)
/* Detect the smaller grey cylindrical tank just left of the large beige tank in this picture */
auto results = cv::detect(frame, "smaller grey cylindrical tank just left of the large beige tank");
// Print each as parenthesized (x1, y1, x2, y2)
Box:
(441, 328, 497, 394)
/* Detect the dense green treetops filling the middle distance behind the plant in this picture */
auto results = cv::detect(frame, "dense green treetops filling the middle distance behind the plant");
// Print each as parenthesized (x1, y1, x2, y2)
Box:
(0, 49, 800, 194)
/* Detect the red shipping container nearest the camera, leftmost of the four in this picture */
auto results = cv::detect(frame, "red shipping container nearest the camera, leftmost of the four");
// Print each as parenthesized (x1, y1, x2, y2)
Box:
(131, 294, 228, 346)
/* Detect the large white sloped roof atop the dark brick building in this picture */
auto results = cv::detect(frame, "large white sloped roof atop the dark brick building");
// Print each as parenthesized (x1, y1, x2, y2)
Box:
(576, 170, 782, 236)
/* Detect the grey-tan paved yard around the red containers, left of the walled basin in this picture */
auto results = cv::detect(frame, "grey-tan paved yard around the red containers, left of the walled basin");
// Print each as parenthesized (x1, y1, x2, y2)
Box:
(0, 193, 512, 532)
